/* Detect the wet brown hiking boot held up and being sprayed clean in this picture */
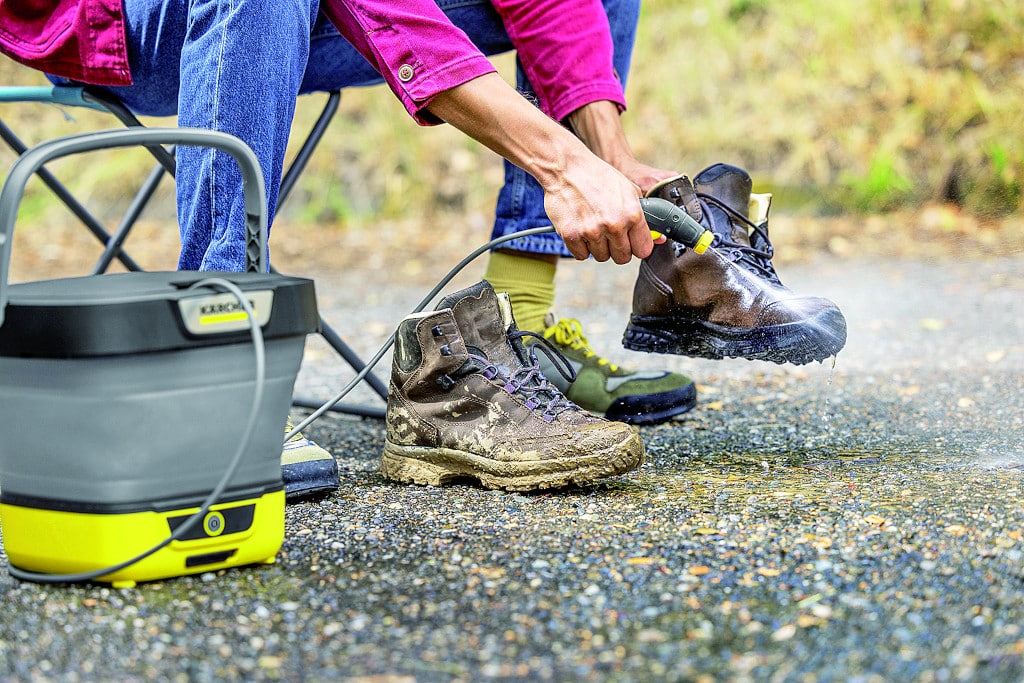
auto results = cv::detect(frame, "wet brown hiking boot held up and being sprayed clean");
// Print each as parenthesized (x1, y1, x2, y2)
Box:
(623, 164, 846, 366)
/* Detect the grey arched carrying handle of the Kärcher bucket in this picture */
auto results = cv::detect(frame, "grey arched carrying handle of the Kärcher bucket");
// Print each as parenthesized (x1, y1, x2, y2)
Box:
(0, 128, 267, 326)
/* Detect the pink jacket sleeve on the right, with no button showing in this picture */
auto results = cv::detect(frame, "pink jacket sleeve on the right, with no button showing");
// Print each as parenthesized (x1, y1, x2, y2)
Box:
(492, 0, 626, 121)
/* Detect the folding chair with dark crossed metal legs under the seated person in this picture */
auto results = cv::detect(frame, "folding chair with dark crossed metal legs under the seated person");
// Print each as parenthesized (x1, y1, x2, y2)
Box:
(0, 86, 387, 418)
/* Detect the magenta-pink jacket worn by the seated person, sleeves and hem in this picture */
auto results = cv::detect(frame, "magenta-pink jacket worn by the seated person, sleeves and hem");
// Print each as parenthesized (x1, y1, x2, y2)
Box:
(0, 0, 625, 124)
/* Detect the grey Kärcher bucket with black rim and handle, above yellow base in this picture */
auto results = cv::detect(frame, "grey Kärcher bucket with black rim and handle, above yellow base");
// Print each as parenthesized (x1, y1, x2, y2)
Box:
(0, 129, 318, 513)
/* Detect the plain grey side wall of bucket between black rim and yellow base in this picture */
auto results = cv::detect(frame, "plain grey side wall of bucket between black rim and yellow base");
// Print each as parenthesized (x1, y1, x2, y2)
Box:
(0, 337, 303, 513)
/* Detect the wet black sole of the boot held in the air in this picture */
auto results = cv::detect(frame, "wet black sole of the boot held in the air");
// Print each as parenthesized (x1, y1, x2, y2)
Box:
(623, 310, 846, 366)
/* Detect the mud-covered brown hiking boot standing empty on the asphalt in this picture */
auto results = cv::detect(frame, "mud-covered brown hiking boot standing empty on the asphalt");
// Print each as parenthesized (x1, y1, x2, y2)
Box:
(381, 281, 645, 490)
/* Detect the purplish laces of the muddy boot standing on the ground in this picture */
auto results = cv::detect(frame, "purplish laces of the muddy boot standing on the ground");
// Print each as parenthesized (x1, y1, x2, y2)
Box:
(469, 330, 579, 423)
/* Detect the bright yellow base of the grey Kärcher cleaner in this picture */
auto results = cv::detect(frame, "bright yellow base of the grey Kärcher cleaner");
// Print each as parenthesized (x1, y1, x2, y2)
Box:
(0, 490, 285, 588)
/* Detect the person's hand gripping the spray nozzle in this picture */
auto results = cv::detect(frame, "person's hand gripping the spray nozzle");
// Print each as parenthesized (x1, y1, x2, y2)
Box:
(544, 154, 654, 264)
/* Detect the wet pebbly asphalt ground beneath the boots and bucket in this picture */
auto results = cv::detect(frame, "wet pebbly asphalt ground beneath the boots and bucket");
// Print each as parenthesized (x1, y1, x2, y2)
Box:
(0, 246, 1024, 682)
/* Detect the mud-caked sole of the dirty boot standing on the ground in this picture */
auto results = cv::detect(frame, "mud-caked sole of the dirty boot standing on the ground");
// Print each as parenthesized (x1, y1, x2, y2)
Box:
(380, 436, 644, 492)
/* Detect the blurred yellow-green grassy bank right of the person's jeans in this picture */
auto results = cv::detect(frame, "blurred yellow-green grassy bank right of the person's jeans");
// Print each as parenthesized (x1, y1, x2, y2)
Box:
(626, 0, 1024, 215)
